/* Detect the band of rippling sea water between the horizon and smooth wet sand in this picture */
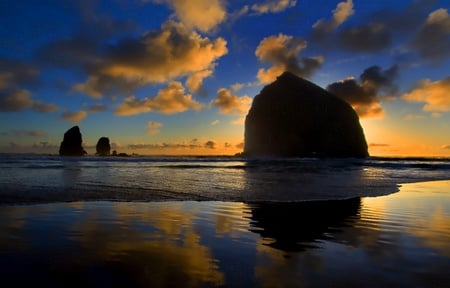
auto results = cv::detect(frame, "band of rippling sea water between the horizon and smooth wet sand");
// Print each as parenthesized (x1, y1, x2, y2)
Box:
(0, 155, 450, 203)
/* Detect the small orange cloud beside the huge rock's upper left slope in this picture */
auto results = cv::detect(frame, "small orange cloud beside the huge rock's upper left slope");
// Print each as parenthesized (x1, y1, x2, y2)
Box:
(212, 88, 252, 115)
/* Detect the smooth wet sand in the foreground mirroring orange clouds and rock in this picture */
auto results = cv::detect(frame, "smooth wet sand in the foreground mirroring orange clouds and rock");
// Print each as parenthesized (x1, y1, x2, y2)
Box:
(0, 181, 450, 287)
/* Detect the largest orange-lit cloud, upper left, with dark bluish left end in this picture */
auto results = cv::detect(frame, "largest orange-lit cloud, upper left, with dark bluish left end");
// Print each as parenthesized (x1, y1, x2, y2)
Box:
(49, 21, 228, 99)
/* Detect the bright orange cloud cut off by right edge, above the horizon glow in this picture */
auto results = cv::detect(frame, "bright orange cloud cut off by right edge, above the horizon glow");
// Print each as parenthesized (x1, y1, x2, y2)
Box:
(401, 76, 450, 112)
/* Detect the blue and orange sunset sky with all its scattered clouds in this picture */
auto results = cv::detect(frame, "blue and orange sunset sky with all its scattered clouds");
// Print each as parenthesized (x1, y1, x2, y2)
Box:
(0, 0, 450, 157)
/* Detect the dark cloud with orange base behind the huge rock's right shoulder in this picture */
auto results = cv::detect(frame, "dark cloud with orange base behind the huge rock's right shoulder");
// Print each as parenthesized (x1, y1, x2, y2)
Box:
(327, 66, 398, 117)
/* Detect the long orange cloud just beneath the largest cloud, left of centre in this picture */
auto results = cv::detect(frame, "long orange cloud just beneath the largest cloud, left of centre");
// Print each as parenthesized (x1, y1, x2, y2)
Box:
(114, 81, 203, 116)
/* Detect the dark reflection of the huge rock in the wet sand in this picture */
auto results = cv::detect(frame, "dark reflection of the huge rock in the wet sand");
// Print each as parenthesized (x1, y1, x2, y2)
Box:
(250, 198, 361, 251)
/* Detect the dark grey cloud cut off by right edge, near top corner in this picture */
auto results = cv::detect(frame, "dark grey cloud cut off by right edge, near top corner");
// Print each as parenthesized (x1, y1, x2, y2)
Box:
(412, 8, 450, 62)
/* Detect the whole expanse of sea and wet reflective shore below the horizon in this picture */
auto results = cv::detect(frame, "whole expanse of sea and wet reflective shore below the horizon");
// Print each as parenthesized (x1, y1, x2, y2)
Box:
(0, 155, 450, 287)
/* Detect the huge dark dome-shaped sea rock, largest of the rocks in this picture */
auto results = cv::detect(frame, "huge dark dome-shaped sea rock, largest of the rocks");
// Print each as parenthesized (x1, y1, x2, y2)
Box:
(243, 72, 369, 157)
